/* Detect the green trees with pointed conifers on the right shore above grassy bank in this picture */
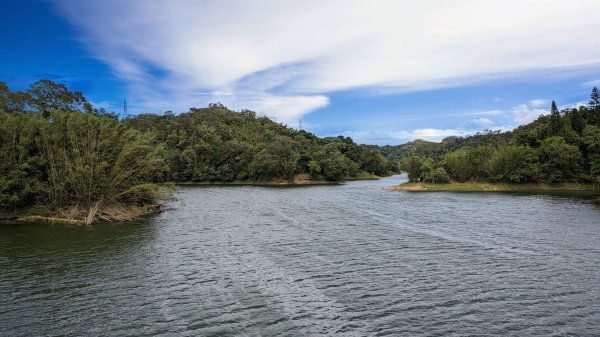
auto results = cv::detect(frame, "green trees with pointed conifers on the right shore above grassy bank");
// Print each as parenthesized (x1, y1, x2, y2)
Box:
(382, 87, 600, 183)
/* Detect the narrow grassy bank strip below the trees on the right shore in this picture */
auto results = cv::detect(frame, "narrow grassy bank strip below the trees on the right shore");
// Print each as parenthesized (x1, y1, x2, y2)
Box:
(385, 182, 600, 194)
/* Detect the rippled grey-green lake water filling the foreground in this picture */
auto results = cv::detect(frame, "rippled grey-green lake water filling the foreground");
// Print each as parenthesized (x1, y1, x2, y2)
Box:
(0, 176, 600, 336)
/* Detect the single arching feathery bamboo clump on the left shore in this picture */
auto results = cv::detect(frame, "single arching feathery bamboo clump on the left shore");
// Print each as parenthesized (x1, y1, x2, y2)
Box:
(36, 111, 167, 208)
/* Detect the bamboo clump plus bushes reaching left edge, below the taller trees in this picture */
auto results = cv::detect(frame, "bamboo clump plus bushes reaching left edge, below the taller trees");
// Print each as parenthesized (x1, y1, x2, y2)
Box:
(0, 110, 167, 209)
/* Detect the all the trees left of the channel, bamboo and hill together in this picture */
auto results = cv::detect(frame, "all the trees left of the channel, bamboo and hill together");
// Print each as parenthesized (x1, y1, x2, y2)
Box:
(0, 80, 399, 212)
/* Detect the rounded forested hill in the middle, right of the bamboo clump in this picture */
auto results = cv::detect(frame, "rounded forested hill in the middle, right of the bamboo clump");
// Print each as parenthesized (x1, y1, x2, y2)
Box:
(124, 104, 398, 181)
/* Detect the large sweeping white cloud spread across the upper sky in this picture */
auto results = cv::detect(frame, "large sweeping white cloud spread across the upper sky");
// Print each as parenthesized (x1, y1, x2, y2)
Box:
(58, 0, 600, 121)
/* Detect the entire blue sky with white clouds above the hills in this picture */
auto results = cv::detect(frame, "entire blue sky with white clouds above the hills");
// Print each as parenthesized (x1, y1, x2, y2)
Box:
(0, 0, 600, 145)
